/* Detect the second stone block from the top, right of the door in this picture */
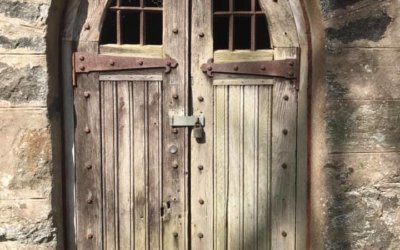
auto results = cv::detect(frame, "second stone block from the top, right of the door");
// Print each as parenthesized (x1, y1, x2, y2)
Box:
(326, 48, 400, 100)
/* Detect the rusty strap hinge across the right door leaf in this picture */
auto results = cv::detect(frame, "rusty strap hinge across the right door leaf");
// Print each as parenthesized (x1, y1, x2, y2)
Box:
(201, 58, 299, 88)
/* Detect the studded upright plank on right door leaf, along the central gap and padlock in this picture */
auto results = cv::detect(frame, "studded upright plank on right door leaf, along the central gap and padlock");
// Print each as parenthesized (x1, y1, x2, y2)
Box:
(190, 0, 216, 250)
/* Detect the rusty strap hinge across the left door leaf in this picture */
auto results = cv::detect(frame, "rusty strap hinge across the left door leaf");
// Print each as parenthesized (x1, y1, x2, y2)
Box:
(72, 52, 178, 86)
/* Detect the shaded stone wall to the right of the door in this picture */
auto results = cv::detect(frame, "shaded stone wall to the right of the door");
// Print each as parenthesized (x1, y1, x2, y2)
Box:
(310, 0, 400, 249)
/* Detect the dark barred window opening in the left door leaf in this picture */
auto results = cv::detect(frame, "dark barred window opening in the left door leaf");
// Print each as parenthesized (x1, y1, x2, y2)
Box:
(100, 0, 163, 45)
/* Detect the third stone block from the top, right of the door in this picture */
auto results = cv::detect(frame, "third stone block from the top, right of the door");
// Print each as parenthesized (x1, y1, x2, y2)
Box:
(325, 100, 400, 153)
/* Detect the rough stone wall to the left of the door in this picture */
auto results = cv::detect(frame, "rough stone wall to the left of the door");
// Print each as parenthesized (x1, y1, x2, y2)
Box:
(0, 0, 63, 249)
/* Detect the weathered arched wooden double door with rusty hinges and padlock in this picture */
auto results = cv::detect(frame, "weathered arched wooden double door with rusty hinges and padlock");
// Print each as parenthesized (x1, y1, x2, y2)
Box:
(73, 0, 299, 250)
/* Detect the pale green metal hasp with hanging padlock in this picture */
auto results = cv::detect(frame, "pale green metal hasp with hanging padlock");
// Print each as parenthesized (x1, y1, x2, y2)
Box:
(171, 114, 205, 142)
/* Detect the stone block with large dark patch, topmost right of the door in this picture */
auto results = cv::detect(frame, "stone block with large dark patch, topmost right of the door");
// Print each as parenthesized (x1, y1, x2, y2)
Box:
(325, 0, 400, 47)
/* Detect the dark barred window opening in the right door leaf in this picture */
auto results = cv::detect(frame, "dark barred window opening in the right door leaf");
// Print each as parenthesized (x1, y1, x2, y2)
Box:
(213, 0, 271, 50)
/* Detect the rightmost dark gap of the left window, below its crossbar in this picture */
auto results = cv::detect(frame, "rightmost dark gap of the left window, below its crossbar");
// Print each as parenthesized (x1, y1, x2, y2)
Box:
(145, 13, 163, 45)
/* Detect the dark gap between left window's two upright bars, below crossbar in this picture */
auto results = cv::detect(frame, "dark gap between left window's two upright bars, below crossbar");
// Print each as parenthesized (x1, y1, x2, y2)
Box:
(121, 12, 140, 44)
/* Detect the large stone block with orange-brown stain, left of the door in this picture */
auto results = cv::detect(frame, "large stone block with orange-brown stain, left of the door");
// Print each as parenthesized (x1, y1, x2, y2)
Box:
(0, 109, 53, 200)
